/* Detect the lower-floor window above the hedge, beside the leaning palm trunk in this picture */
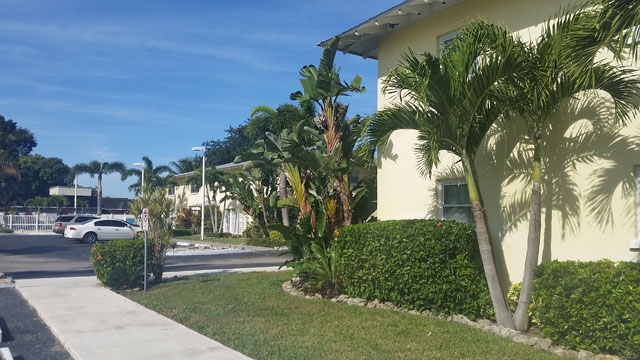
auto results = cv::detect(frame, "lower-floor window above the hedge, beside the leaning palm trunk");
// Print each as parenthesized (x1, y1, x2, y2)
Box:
(440, 179, 474, 225)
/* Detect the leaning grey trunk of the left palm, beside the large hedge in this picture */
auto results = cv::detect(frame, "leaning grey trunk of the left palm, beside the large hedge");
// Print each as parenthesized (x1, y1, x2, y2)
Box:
(463, 159, 515, 329)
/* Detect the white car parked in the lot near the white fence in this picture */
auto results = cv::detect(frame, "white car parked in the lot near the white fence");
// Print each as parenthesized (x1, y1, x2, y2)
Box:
(64, 219, 141, 244)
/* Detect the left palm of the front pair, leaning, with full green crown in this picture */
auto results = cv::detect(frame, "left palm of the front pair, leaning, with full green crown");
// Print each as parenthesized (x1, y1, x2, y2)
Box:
(367, 21, 522, 328)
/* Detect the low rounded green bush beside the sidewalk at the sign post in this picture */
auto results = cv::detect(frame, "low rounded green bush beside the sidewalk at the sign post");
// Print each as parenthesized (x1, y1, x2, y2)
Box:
(91, 239, 155, 290)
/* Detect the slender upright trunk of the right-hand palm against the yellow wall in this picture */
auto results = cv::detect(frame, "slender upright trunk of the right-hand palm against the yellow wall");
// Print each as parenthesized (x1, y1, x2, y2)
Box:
(513, 148, 542, 331)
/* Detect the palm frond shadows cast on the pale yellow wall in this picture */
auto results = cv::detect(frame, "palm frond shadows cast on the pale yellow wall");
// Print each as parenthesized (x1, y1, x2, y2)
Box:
(476, 97, 640, 286)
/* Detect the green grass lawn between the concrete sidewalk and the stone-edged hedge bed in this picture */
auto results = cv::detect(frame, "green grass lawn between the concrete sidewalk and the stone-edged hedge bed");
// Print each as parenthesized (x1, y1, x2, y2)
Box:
(124, 271, 557, 360)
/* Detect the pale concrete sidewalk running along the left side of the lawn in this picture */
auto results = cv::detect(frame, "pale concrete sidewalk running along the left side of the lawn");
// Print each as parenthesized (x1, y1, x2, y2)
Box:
(15, 268, 273, 360)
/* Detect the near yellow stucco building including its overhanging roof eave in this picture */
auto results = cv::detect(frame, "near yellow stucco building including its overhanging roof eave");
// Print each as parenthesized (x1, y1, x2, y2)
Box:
(321, 0, 640, 282)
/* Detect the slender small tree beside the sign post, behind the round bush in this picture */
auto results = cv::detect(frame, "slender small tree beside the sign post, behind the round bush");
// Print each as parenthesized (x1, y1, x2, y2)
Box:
(131, 188, 175, 282)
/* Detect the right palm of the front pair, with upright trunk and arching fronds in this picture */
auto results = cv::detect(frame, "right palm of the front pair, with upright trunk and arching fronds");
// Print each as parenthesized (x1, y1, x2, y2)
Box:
(513, 4, 640, 330)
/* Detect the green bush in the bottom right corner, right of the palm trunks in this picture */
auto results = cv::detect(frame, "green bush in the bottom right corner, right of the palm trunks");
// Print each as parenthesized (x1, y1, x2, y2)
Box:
(531, 260, 640, 359)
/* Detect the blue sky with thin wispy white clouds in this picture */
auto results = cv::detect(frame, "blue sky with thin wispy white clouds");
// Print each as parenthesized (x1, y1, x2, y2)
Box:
(0, 0, 400, 196)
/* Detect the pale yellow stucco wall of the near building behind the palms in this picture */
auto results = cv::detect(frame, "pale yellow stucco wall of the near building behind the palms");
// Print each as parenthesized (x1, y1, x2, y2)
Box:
(378, 0, 640, 282)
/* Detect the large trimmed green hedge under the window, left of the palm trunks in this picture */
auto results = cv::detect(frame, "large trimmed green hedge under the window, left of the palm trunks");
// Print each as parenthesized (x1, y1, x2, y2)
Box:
(334, 220, 493, 319)
